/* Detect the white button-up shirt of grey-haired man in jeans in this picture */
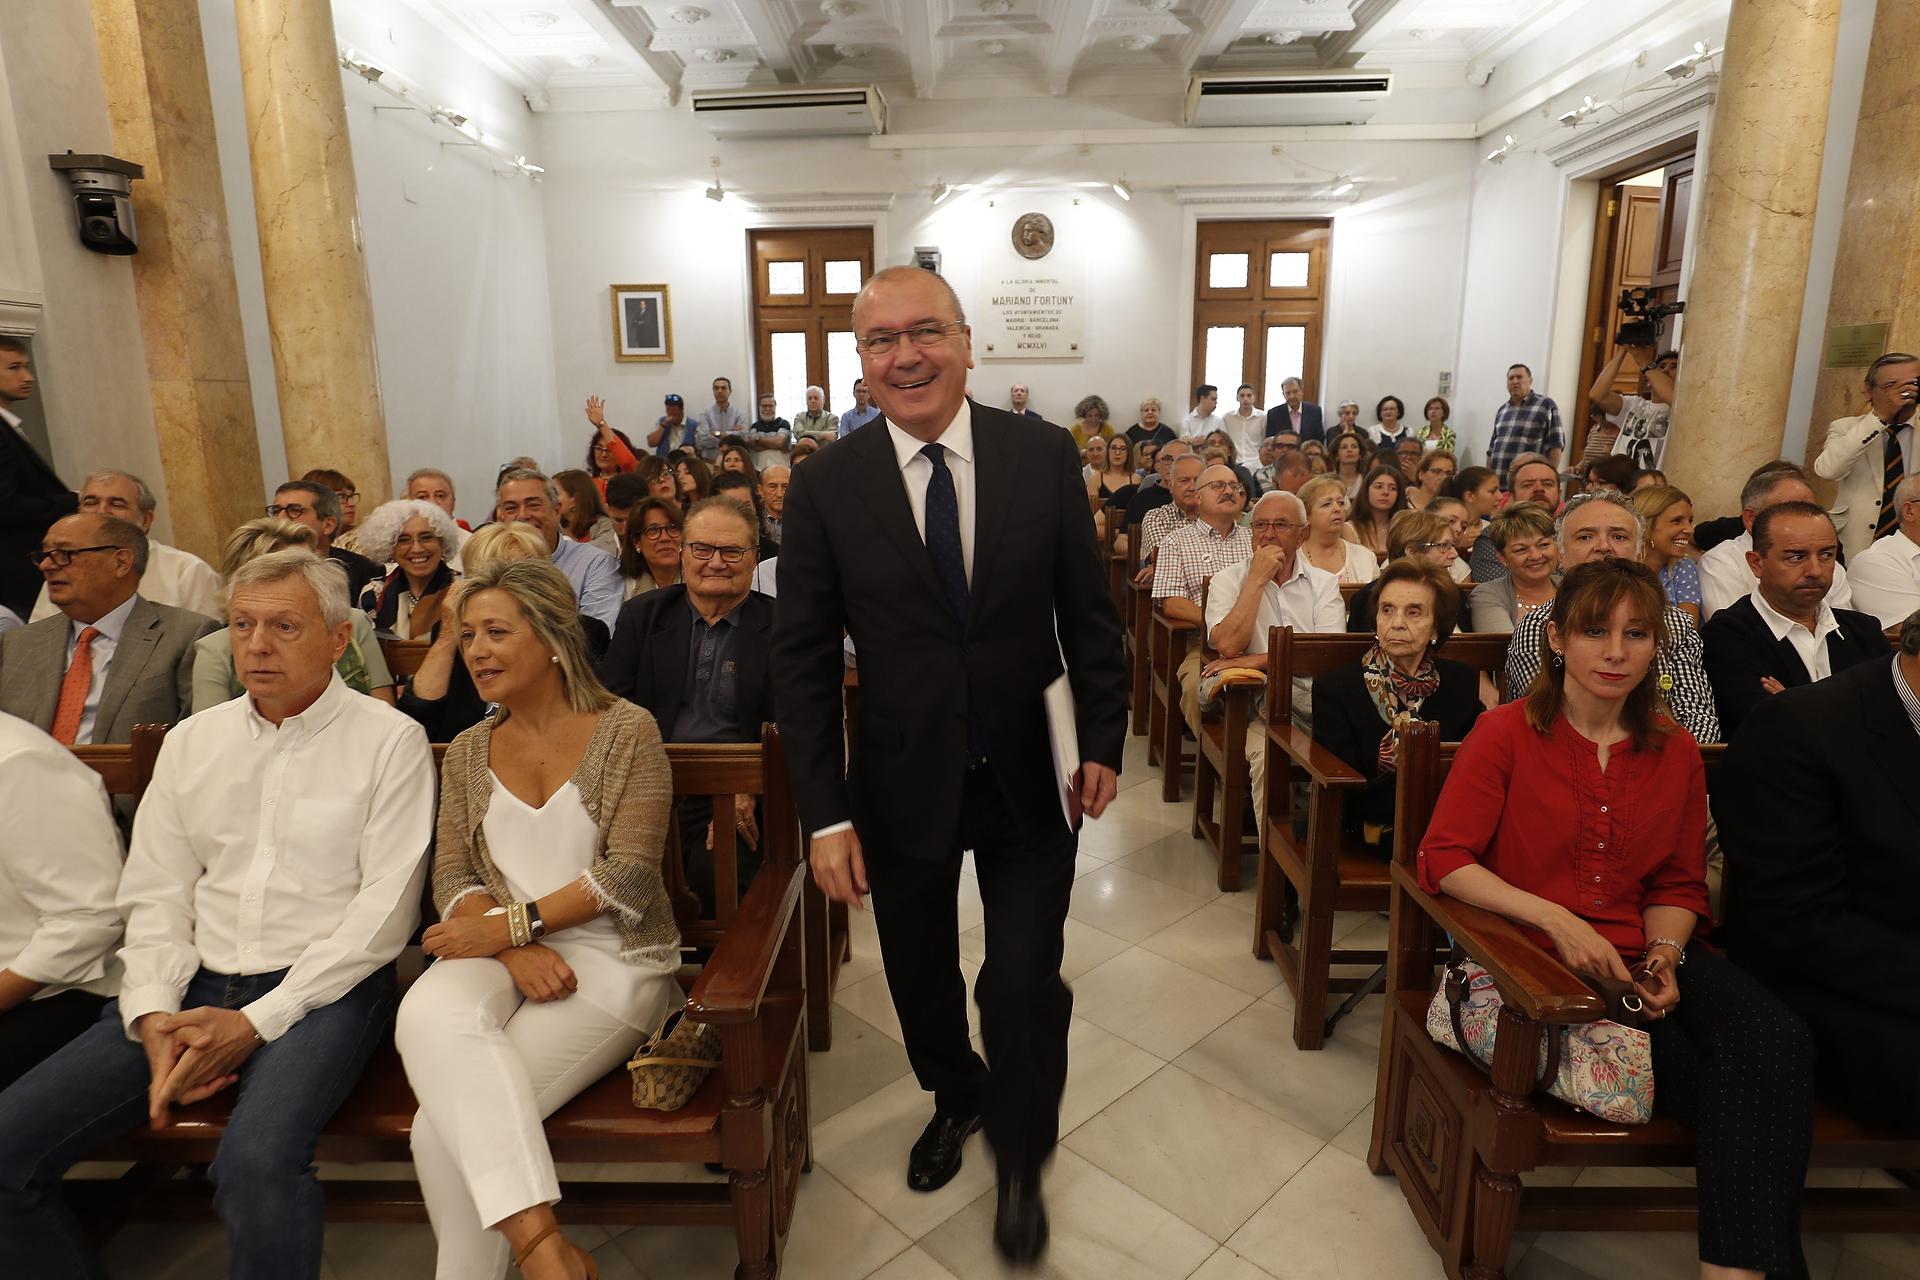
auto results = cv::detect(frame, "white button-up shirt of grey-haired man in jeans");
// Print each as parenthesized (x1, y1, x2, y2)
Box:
(119, 672, 434, 1040)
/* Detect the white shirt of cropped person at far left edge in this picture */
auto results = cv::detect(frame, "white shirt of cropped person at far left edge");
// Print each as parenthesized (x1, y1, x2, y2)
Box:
(0, 712, 121, 1000)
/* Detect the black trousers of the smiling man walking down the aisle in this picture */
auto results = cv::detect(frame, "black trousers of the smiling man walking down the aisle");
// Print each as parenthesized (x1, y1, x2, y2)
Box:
(864, 766, 1077, 1176)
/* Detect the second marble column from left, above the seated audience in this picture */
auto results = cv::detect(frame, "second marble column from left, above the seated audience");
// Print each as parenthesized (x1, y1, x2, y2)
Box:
(234, 0, 392, 510)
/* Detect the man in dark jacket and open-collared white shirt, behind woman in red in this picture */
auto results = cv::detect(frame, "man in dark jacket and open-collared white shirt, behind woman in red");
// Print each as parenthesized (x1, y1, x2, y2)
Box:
(1699, 503, 1889, 741)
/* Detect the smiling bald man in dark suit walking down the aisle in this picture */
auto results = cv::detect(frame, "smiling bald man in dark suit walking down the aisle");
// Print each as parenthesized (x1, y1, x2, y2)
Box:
(774, 267, 1127, 1263)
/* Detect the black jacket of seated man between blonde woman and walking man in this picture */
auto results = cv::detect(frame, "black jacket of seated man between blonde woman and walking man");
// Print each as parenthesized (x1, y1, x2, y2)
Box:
(599, 583, 775, 743)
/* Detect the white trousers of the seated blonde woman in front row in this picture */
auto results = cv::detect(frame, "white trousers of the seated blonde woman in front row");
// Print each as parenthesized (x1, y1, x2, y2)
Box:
(394, 948, 680, 1280)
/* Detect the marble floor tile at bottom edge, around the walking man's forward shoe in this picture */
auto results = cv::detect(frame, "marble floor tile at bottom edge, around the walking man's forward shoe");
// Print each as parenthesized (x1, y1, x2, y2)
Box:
(920, 1150, 1215, 1280)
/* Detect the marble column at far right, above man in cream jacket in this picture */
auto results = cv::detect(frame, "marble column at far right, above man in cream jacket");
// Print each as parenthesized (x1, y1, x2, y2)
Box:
(1807, 2, 1920, 501)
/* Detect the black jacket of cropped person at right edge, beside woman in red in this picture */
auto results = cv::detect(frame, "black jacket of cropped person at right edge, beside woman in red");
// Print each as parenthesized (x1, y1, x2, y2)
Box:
(1720, 658, 1920, 1128)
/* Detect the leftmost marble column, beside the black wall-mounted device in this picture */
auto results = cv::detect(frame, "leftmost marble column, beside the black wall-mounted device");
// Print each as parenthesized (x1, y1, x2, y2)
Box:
(92, 0, 263, 564)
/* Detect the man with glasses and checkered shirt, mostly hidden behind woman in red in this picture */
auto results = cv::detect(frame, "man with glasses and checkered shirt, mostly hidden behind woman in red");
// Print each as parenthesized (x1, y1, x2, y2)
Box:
(1507, 489, 1720, 743)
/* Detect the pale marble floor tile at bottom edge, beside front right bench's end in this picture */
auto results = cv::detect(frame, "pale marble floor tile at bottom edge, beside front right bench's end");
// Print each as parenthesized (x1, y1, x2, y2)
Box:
(1227, 1148, 1446, 1280)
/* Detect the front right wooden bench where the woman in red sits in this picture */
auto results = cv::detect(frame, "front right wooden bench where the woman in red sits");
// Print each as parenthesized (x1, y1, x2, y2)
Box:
(1367, 725, 1920, 1280)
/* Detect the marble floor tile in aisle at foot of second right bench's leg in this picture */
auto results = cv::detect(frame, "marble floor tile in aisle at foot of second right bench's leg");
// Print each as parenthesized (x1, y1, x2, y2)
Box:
(1173, 1000, 1379, 1143)
